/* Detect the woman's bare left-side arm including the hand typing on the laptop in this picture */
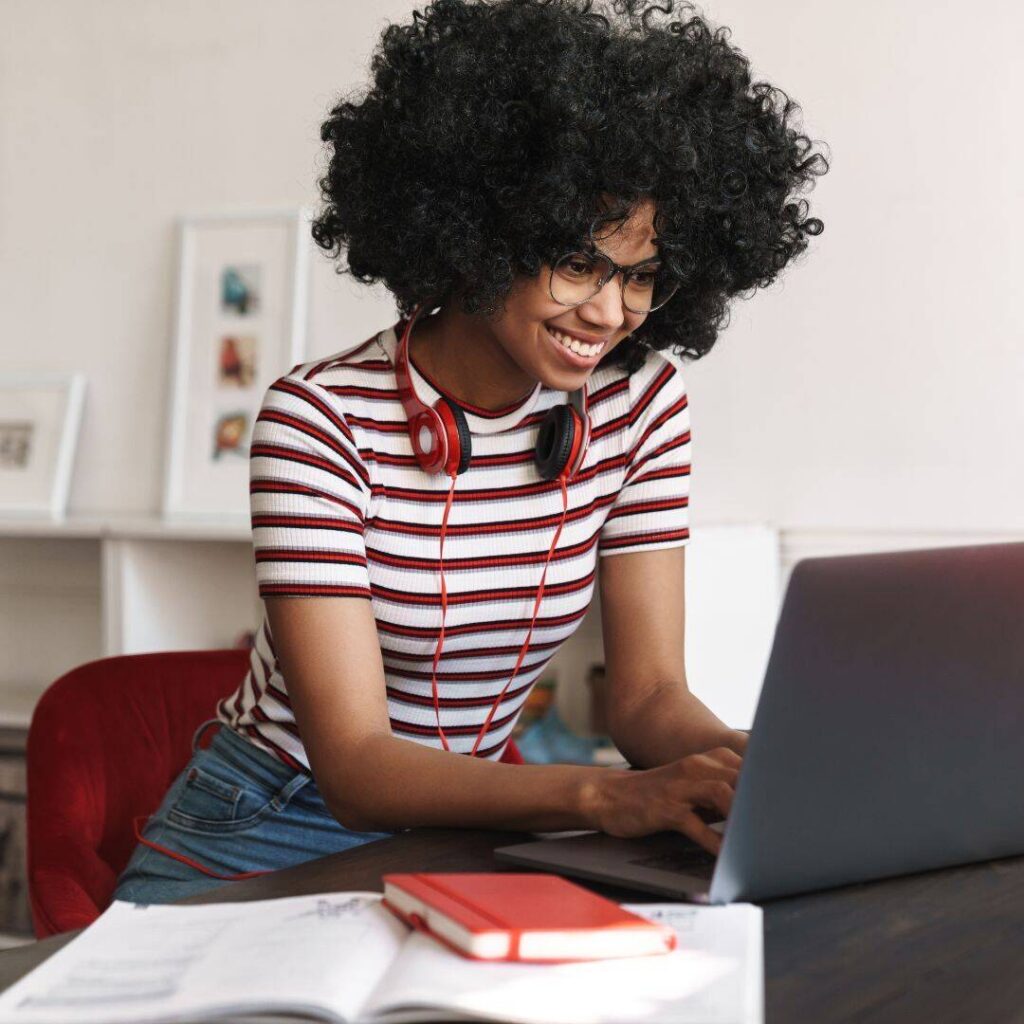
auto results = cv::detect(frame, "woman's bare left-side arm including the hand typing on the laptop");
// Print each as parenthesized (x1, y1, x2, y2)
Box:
(265, 597, 735, 850)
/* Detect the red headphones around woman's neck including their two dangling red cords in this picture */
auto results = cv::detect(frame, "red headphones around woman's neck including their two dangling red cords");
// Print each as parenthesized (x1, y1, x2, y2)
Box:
(394, 303, 590, 757)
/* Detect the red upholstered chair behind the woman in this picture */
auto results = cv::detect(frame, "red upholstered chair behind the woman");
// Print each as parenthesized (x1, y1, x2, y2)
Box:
(26, 649, 522, 938)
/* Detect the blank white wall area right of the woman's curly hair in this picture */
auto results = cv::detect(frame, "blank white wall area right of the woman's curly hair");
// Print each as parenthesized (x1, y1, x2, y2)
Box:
(689, 0, 1024, 534)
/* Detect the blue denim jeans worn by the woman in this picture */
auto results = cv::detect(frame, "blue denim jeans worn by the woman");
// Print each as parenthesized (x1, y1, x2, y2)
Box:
(114, 719, 394, 903)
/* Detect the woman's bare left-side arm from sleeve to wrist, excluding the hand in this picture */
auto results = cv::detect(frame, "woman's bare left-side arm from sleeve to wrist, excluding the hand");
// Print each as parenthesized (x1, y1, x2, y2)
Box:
(266, 597, 593, 831)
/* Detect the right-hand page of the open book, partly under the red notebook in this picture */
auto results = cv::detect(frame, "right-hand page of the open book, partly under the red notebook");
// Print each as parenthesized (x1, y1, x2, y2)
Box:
(364, 903, 764, 1024)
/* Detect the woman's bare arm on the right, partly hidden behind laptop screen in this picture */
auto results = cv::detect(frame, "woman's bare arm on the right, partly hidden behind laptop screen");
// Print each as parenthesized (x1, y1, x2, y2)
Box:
(600, 547, 746, 768)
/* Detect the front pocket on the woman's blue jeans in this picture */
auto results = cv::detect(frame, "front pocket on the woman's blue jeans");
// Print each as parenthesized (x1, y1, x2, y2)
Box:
(167, 757, 295, 833)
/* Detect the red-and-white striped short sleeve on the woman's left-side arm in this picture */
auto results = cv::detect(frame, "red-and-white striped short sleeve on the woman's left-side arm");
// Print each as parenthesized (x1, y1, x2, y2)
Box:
(249, 371, 371, 597)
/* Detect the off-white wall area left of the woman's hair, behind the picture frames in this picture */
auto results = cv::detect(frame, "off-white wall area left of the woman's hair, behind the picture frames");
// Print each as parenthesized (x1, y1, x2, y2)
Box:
(0, 0, 412, 513)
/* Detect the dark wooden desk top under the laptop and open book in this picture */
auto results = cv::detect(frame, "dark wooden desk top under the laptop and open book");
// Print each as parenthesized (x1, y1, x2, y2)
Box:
(0, 829, 1024, 1024)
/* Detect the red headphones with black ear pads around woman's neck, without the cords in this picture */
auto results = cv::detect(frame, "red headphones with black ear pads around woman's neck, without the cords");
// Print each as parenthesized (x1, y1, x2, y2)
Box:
(394, 304, 590, 480)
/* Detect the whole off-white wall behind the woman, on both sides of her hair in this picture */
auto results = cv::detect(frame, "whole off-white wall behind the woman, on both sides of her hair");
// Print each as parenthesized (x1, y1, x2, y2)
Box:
(0, 0, 1024, 531)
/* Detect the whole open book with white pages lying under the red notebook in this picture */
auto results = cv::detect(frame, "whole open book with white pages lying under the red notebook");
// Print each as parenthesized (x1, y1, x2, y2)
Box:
(0, 892, 764, 1024)
